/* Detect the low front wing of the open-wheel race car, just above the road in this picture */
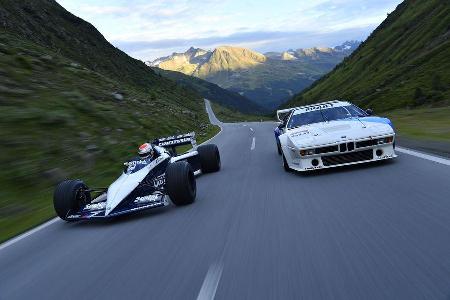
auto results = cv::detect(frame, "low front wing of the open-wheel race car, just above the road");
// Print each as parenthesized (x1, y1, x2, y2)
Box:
(66, 196, 169, 221)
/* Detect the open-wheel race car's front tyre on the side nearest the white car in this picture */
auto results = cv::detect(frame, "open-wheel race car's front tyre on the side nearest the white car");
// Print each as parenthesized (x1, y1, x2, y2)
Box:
(166, 161, 197, 206)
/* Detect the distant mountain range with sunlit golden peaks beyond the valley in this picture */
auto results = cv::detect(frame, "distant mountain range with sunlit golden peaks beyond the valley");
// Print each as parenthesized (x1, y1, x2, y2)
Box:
(147, 41, 360, 110)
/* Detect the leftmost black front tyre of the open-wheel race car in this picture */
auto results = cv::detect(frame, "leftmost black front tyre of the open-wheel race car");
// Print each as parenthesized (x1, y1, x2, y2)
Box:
(53, 180, 91, 221)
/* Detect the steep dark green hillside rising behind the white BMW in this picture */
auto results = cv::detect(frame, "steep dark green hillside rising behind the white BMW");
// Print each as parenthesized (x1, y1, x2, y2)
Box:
(283, 0, 450, 112)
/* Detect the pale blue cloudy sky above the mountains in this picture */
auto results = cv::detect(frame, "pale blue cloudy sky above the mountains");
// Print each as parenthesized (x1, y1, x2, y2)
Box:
(57, 0, 402, 61)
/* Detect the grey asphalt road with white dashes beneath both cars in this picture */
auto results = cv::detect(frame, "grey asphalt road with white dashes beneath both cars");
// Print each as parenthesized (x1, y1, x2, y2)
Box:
(0, 101, 450, 299)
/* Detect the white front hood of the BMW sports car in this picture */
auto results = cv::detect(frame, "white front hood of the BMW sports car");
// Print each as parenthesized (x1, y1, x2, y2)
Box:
(285, 117, 394, 148)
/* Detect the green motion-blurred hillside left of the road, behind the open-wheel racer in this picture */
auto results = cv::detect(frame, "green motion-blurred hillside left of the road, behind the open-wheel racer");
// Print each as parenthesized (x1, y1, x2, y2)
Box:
(0, 0, 216, 241)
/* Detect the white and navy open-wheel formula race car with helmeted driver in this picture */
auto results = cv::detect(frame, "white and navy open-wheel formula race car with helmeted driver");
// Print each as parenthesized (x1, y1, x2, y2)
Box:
(53, 133, 221, 221)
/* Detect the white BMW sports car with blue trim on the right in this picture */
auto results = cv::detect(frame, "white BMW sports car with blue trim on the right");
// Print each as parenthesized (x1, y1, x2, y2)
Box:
(275, 100, 396, 171)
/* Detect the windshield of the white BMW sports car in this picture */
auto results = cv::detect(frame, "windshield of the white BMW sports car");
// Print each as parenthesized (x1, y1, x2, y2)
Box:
(288, 105, 367, 128)
